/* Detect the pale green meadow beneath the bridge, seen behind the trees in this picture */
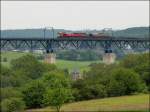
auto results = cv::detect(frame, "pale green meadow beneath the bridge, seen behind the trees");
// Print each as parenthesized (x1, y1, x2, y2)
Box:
(1, 52, 100, 72)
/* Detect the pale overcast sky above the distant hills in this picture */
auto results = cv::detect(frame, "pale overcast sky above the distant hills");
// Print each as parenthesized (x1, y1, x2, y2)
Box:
(1, 1, 149, 30)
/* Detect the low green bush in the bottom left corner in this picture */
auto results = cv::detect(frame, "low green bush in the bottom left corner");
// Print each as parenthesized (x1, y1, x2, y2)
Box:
(1, 98, 25, 112)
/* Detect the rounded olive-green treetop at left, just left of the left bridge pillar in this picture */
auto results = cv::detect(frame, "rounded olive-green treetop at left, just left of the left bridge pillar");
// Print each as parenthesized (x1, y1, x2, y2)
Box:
(11, 54, 44, 79)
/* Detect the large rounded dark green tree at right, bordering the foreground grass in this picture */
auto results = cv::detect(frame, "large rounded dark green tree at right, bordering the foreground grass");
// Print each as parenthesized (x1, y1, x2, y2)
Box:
(108, 68, 142, 96)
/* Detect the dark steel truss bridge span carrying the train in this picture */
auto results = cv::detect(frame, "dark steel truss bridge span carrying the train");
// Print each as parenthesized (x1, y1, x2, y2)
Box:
(0, 37, 150, 53)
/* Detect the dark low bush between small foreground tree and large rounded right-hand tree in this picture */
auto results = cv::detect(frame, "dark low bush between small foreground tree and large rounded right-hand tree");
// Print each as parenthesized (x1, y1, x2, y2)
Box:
(72, 80, 107, 101)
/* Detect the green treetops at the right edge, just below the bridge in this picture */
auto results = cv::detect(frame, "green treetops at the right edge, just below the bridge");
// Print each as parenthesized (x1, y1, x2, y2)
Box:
(120, 53, 150, 90)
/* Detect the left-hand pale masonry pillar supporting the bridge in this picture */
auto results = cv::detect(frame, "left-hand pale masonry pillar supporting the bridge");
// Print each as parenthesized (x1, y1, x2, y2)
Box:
(44, 53, 56, 64)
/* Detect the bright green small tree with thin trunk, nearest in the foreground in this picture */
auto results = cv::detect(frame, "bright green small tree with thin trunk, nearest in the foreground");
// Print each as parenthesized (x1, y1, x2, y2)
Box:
(42, 71, 73, 112)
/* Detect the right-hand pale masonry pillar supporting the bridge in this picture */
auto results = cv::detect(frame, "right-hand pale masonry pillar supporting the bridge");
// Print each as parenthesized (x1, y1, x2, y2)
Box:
(103, 53, 116, 64)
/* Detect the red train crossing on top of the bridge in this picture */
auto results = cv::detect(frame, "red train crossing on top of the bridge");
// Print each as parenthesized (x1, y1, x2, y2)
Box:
(58, 32, 110, 38)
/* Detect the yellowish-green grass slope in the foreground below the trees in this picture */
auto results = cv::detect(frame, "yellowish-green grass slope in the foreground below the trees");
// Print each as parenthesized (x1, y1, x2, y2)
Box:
(27, 94, 149, 112)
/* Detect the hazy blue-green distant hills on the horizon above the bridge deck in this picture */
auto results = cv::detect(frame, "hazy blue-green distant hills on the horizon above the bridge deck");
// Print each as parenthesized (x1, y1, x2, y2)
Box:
(1, 27, 149, 38)
